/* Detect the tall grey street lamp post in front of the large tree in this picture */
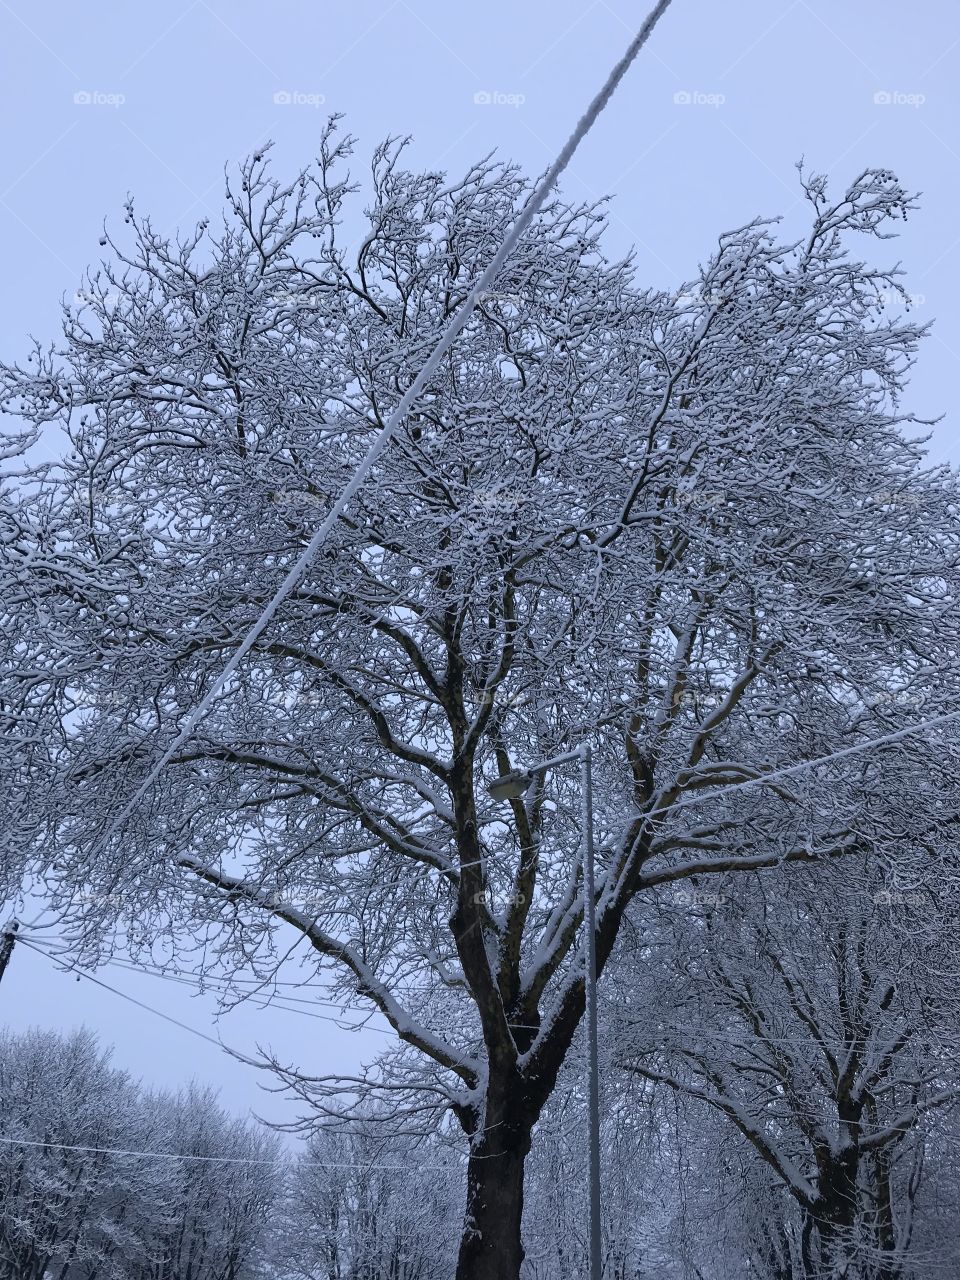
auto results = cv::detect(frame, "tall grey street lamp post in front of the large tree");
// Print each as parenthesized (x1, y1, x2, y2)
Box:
(488, 744, 602, 1280)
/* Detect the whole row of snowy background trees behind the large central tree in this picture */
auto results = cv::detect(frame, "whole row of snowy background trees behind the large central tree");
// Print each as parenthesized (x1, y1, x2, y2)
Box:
(0, 880, 960, 1280)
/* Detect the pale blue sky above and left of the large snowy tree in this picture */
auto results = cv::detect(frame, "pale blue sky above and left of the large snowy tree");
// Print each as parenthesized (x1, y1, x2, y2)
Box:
(0, 0, 960, 1115)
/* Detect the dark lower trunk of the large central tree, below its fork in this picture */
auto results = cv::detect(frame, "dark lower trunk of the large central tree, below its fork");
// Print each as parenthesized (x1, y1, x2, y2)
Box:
(457, 1121, 532, 1280)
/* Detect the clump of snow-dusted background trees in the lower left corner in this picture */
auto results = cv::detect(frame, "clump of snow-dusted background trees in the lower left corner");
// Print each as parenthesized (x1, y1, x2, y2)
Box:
(0, 1030, 283, 1280)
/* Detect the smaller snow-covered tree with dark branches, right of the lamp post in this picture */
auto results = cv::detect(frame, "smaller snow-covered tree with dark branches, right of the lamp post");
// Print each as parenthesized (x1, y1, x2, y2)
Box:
(616, 859, 960, 1280)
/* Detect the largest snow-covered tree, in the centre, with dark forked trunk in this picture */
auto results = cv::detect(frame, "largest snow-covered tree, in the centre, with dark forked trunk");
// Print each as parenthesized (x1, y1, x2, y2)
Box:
(3, 123, 957, 1280)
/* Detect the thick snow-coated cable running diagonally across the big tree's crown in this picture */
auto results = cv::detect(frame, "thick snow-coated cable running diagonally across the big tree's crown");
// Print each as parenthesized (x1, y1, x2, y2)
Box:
(90, 0, 671, 860)
